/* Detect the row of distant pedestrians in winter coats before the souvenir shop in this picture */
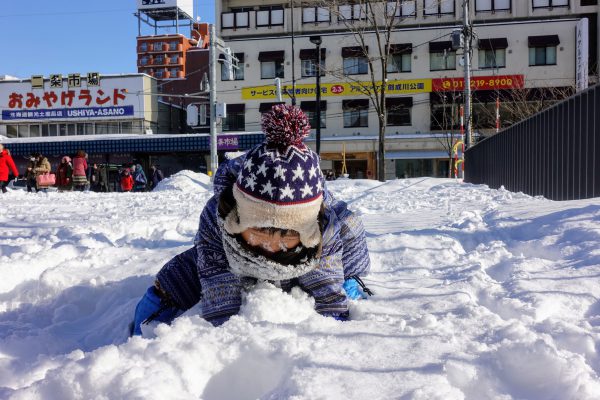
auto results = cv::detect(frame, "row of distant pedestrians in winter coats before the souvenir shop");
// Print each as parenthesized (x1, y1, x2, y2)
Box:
(0, 144, 164, 193)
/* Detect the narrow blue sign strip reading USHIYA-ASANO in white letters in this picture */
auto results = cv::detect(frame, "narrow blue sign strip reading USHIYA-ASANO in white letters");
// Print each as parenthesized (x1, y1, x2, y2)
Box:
(2, 106, 133, 121)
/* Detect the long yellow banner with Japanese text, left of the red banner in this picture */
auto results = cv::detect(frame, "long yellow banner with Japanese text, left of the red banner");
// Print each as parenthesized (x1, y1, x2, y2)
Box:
(242, 79, 431, 100)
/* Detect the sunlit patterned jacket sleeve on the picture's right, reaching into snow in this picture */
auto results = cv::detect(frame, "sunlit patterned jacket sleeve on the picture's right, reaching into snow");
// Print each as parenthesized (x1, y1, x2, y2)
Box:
(298, 217, 349, 320)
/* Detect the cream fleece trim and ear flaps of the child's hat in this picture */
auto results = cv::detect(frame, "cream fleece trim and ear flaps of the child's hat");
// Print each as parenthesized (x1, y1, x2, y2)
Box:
(223, 185, 323, 247)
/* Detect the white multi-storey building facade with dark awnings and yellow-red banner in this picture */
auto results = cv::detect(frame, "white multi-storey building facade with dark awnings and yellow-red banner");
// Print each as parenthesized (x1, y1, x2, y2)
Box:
(216, 0, 599, 178)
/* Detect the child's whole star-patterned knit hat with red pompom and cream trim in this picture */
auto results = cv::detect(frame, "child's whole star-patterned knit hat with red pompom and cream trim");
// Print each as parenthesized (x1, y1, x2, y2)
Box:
(223, 104, 324, 247)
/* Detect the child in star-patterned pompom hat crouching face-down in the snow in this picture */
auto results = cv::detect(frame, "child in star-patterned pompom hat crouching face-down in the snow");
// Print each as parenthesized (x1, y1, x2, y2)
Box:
(132, 105, 371, 335)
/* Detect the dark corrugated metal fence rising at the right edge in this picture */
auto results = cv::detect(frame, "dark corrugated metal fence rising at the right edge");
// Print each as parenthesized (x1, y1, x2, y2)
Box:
(465, 85, 600, 200)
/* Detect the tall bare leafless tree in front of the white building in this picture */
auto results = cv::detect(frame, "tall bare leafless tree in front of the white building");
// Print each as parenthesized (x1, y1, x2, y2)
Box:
(308, 0, 410, 182)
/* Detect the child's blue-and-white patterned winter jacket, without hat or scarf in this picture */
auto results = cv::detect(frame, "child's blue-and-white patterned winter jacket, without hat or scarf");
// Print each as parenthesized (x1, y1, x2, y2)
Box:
(157, 156, 370, 325)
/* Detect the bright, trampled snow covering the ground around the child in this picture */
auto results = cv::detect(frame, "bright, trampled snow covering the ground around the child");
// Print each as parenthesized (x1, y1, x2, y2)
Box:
(0, 173, 600, 400)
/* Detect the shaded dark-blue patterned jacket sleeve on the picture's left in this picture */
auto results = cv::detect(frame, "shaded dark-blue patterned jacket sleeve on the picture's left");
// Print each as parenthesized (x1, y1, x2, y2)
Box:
(195, 196, 242, 325)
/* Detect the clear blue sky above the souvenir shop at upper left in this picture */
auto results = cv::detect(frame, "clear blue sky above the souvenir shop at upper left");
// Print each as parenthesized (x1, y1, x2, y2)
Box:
(0, 0, 214, 78)
